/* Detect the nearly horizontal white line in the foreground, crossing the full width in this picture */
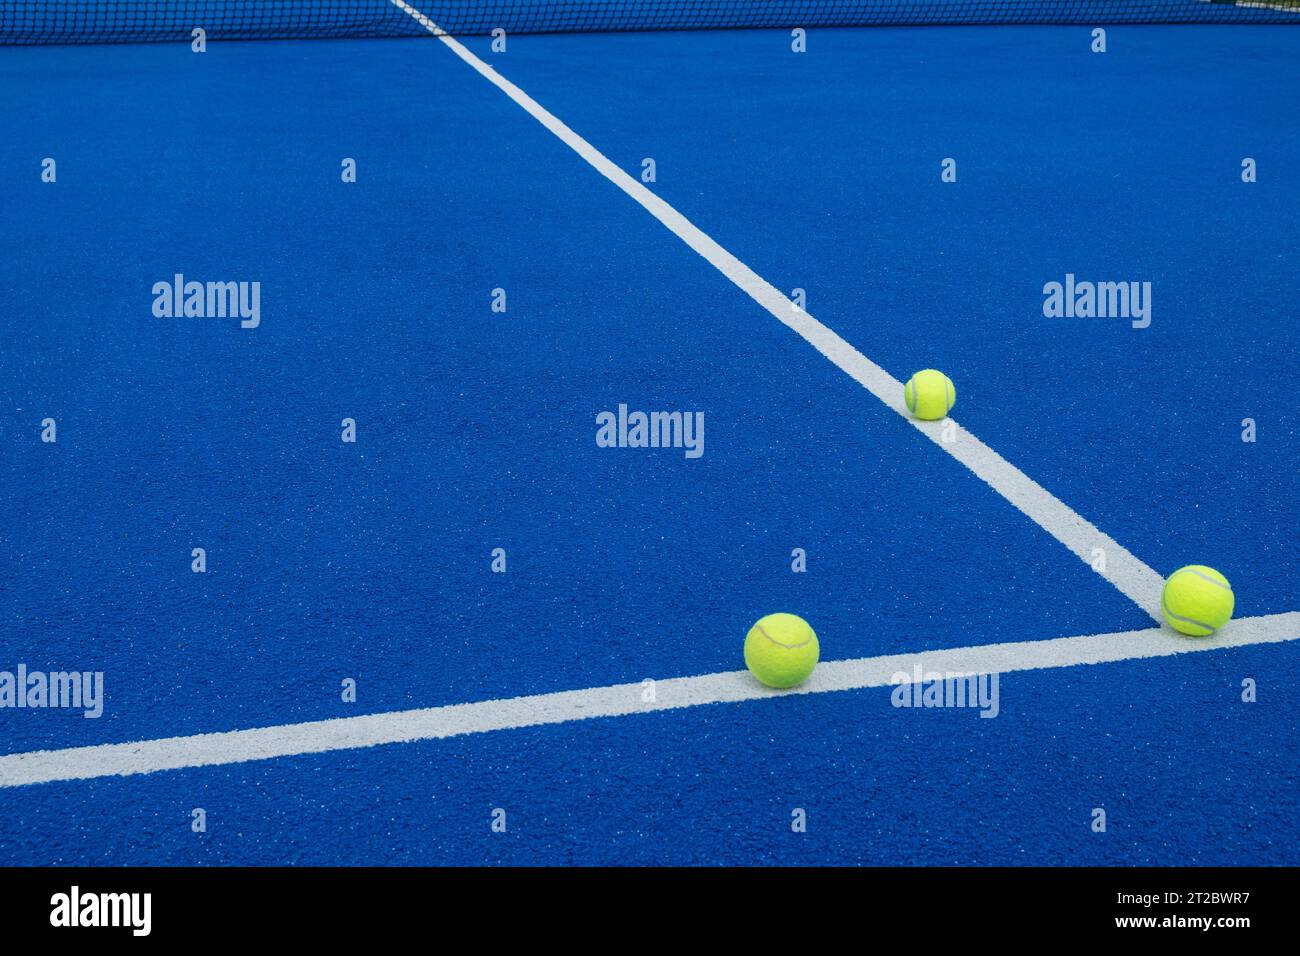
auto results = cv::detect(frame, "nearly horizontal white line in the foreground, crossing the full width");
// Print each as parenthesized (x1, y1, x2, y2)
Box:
(0, 611, 1300, 788)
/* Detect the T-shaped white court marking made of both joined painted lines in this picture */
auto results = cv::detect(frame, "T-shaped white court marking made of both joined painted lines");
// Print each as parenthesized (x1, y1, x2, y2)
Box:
(0, 9, 1279, 787)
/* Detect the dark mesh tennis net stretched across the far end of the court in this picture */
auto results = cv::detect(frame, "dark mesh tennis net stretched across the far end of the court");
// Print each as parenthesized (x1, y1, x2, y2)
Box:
(0, 0, 1300, 44)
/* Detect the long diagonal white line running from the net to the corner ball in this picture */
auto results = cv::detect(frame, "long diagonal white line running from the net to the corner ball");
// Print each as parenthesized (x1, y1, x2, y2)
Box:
(391, 0, 1165, 620)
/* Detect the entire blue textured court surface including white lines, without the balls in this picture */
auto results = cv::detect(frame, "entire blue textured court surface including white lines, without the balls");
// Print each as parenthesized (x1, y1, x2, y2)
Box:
(0, 0, 1300, 865)
